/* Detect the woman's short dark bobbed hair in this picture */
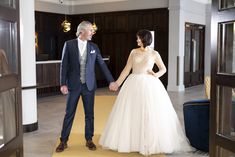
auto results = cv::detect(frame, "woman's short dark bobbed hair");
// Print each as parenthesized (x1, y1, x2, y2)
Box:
(136, 29, 152, 48)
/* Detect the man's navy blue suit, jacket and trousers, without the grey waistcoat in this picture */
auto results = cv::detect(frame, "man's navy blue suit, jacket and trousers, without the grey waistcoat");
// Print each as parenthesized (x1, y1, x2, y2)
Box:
(60, 39, 114, 142)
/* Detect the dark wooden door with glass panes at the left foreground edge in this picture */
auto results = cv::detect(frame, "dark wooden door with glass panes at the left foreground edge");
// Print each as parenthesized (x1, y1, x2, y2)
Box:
(0, 0, 23, 157)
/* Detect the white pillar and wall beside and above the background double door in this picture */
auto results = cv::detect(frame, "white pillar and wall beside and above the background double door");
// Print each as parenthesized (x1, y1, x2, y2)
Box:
(167, 0, 208, 91)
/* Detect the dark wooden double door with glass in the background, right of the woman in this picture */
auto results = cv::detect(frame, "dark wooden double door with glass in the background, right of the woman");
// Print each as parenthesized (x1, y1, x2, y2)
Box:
(184, 23, 205, 87)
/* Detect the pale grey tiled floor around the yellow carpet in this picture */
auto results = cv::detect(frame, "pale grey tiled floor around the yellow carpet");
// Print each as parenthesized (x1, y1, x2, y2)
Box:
(24, 85, 208, 157)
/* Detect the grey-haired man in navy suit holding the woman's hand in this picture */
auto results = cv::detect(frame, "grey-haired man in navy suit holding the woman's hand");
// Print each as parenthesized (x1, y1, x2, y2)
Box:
(56, 21, 117, 152)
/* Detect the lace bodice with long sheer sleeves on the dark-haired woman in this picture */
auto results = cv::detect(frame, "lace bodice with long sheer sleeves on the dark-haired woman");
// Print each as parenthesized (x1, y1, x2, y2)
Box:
(117, 48, 166, 85)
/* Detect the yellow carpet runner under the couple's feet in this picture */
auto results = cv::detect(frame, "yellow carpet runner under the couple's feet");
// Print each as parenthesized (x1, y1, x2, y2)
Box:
(52, 96, 165, 157)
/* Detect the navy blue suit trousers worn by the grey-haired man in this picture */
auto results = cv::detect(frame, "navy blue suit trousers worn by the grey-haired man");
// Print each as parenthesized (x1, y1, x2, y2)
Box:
(60, 83, 95, 142)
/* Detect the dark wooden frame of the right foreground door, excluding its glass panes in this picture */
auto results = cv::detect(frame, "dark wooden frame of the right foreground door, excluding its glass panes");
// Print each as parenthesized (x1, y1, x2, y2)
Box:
(209, 0, 235, 157)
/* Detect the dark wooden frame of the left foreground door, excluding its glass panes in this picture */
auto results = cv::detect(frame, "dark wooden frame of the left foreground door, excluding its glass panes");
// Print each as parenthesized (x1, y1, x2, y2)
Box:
(0, 0, 23, 157)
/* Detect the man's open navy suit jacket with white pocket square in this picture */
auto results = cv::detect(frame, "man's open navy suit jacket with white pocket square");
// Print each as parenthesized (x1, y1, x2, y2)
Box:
(60, 39, 114, 91)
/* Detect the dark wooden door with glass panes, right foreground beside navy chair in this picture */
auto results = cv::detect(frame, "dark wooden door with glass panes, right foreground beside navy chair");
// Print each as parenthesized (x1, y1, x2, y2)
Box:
(210, 0, 235, 157)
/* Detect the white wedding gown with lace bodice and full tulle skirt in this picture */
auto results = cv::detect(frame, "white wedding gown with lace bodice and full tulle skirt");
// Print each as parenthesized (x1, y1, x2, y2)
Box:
(99, 49, 192, 155)
